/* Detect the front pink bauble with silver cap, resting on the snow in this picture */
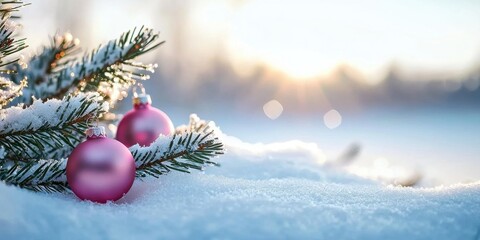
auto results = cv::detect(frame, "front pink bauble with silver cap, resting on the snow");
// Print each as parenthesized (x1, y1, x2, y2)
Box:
(67, 127, 135, 203)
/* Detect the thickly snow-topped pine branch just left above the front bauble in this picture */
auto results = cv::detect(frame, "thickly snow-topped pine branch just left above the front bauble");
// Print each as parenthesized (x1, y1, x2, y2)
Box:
(0, 93, 108, 160)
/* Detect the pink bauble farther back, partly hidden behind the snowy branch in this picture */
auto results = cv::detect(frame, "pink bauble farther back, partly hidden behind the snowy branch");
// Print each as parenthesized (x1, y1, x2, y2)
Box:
(115, 94, 175, 147)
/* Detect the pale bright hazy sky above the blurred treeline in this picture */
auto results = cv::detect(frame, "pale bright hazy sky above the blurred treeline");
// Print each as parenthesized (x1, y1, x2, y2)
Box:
(22, 0, 480, 83)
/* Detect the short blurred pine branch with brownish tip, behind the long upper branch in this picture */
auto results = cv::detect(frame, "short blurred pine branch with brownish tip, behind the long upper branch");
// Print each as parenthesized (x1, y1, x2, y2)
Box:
(9, 33, 80, 105)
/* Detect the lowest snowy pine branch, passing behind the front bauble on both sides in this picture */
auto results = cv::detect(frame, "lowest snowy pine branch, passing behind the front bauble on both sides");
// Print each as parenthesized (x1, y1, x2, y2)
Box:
(0, 115, 224, 192)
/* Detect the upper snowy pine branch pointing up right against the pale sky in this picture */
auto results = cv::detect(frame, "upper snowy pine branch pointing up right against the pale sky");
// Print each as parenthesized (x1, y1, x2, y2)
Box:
(47, 27, 164, 103)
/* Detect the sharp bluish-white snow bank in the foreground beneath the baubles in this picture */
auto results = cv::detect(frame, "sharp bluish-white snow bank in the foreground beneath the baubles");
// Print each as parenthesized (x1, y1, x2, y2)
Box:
(0, 136, 480, 239)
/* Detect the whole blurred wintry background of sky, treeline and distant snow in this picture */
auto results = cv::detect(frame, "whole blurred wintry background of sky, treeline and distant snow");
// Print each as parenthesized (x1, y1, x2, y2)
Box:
(21, 0, 480, 186)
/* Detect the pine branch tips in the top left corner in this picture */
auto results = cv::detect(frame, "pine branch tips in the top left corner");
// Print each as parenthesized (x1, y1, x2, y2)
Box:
(0, 0, 27, 67)
